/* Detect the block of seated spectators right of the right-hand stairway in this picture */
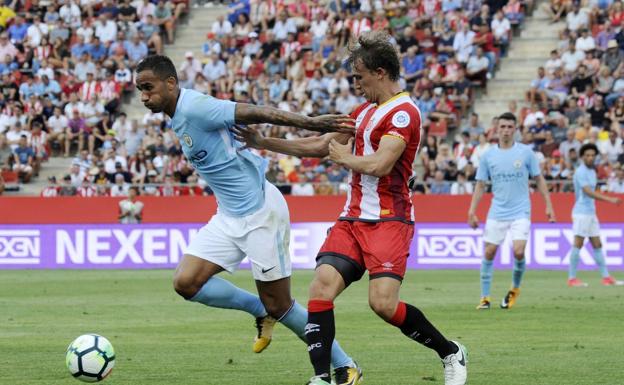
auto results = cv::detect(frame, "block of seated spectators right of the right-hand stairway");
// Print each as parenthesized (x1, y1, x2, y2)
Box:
(510, 0, 624, 193)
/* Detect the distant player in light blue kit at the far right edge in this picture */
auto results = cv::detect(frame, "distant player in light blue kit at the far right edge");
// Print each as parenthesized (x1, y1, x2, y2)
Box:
(568, 143, 624, 287)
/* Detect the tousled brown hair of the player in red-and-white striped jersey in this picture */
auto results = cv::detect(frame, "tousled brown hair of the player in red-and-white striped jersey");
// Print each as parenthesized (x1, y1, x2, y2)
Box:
(347, 31, 401, 81)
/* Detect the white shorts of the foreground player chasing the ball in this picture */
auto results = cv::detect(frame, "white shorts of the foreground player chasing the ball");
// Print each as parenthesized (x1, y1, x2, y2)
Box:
(186, 182, 292, 281)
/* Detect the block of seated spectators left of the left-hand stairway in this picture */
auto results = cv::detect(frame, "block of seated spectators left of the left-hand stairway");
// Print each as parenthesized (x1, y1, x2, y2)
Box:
(0, 0, 187, 191)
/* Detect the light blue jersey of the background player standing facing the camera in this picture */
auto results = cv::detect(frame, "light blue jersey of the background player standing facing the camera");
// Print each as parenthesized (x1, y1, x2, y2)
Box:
(476, 143, 540, 221)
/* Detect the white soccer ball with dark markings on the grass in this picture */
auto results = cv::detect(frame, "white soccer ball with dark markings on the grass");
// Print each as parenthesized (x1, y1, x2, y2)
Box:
(65, 334, 115, 382)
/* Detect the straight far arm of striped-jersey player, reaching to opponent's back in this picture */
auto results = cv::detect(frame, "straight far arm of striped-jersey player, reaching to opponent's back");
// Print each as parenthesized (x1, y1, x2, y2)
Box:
(232, 126, 351, 158)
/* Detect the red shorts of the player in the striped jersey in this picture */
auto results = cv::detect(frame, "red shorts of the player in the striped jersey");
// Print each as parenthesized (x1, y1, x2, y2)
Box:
(317, 221, 414, 284)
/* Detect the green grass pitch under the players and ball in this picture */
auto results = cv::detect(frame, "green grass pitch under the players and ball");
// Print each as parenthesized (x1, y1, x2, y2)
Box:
(0, 270, 624, 385)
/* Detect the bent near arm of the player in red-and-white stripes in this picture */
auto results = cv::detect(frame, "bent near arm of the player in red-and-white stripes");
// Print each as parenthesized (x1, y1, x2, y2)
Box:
(329, 135, 407, 178)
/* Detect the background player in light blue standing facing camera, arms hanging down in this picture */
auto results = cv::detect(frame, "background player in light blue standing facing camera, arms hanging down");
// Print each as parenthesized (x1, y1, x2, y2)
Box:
(468, 112, 555, 309)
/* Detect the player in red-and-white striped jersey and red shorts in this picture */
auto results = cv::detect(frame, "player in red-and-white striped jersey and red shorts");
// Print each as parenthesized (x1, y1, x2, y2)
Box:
(234, 32, 467, 385)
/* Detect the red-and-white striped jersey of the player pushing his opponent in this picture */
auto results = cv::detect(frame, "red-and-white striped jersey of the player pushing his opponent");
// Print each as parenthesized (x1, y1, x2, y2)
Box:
(340, 92, 421, 222)
